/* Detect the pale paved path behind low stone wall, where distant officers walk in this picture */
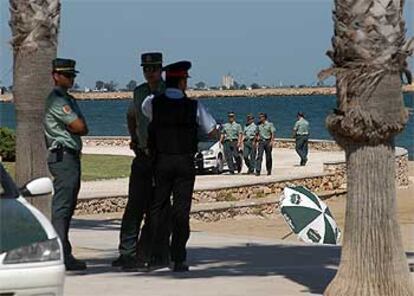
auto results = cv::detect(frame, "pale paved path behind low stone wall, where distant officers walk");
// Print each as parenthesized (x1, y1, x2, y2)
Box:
(79, 147, 345, 198)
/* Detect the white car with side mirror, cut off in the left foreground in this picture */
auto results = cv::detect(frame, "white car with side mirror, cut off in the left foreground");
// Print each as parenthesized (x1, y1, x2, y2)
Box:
(0, 163, 65, 296)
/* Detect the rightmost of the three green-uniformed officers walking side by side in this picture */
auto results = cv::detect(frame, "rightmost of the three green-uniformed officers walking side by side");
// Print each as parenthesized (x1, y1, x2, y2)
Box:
(256, 113, 276, 176)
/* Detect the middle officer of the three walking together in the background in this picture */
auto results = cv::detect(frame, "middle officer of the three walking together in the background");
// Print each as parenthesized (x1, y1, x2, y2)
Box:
(243, 114, 257, 174)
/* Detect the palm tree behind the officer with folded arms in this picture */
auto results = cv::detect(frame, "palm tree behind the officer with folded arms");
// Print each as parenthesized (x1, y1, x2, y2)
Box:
(10, 0, 60, 215)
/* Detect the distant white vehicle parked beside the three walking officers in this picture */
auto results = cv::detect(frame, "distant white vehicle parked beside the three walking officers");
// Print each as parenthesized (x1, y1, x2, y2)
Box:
(195, 140, 226, 174)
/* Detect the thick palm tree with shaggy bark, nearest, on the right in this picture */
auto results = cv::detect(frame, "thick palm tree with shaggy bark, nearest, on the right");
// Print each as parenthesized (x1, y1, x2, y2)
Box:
(320, 0, 414, 296)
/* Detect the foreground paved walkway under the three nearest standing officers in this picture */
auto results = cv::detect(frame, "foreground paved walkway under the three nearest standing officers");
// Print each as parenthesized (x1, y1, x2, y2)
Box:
(65, 217, 339, 296)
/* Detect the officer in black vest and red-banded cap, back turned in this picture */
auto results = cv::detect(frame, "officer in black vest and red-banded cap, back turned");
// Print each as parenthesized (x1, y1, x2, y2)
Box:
(142, 61, 216, 272)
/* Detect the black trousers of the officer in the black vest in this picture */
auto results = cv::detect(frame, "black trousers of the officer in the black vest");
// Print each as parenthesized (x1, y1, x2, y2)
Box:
(146, 153, 196, 262)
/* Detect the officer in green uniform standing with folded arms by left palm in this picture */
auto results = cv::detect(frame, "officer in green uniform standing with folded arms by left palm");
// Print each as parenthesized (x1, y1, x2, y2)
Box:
(44, 59, 88, 270)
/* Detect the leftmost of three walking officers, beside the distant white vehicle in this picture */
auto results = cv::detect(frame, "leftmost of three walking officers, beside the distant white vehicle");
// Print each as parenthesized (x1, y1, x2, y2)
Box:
(220, 112, 243, 174)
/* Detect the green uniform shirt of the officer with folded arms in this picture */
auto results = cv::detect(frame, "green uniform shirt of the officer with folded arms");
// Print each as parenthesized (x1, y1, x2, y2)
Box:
(43, 87, 83, 151)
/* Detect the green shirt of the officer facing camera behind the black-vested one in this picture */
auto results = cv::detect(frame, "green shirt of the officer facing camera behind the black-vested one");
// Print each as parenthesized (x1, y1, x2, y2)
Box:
(129, 80, 165, 149)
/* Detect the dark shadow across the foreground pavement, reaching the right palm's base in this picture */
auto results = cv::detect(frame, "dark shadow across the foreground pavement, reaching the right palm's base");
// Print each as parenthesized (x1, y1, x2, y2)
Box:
(72, 244, 340, 293)
